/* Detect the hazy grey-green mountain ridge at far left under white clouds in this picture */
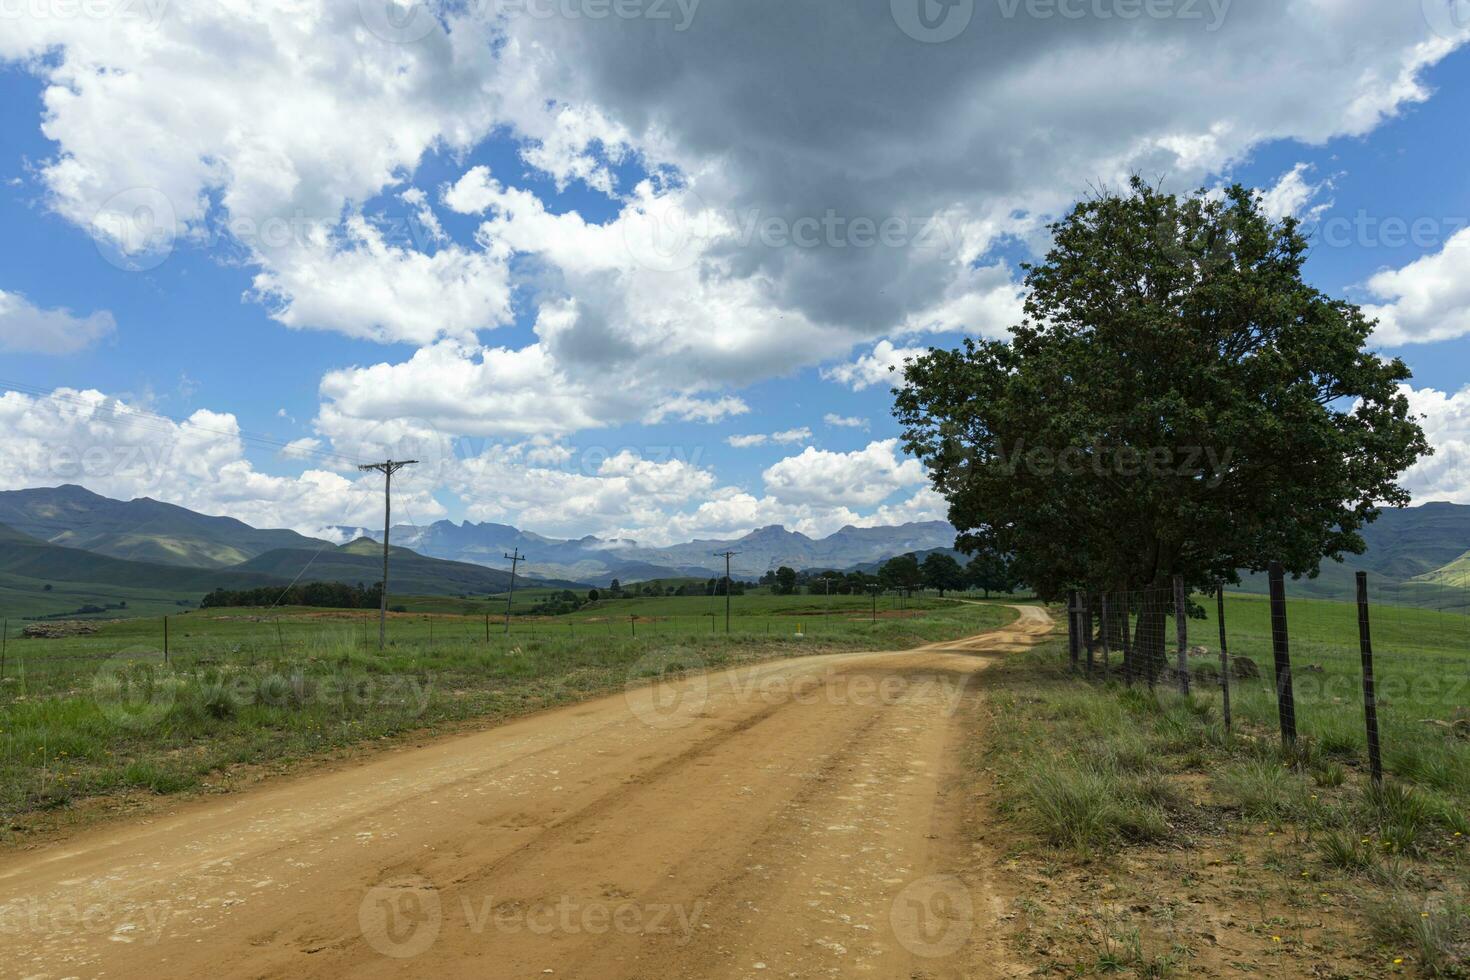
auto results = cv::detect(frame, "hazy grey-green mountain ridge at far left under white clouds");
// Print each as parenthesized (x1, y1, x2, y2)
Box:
(0, 486, 323, 569)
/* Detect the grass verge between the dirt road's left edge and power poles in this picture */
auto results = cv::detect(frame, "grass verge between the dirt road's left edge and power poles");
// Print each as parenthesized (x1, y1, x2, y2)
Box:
(0, 604, 1014, 843)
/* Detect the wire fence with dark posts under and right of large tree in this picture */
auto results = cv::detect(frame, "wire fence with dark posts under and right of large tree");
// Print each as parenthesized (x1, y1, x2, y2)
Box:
(1067, 566, 1470, 789)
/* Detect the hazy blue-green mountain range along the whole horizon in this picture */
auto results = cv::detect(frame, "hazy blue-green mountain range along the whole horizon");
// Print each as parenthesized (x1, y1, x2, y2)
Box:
(0, 486, 1470, 617)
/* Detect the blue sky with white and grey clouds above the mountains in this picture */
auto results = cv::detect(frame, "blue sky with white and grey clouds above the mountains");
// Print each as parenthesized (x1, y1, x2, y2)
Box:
(0, 0, 1470, 541)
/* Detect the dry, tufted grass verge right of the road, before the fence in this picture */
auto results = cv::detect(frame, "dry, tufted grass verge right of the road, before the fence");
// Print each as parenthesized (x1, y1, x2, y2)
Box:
(970, 638, 1470, 977)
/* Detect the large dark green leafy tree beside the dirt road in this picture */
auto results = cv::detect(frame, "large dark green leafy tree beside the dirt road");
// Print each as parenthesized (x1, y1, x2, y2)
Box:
(895, 179, 1427, 675)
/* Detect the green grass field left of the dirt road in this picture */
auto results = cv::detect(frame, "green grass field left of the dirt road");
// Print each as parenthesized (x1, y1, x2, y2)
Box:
(0, 595, 1014, 835)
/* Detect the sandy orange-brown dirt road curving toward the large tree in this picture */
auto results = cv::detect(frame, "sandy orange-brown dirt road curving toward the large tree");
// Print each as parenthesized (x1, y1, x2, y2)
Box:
(0, 607, 1050, 980)
